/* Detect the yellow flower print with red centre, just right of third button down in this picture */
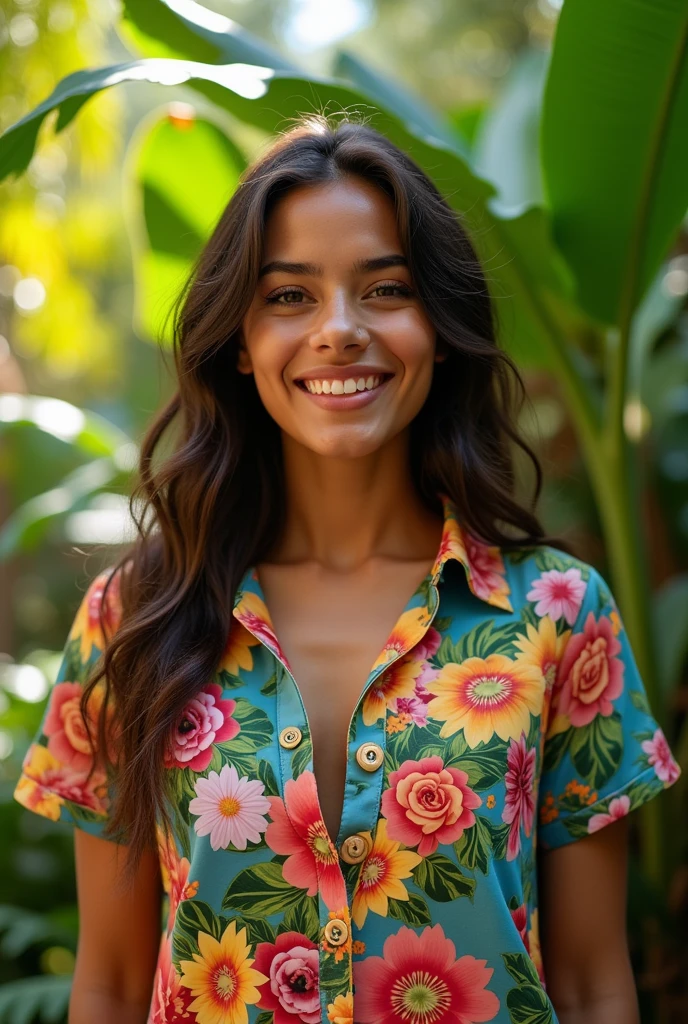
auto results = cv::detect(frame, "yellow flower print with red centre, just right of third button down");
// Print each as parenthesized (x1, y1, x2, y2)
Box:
(351, 818, 422, 928)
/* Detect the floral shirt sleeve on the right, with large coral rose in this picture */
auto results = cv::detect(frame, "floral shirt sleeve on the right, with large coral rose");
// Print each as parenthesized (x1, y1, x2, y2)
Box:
(539, 566, 681, 849)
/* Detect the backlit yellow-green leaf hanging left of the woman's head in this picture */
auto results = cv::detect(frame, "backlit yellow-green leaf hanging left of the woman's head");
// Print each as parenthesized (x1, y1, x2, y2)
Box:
(126, 106, 246, 342)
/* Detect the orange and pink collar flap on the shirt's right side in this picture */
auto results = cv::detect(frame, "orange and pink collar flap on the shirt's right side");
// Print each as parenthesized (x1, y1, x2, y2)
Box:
(431, 493, 514, 611)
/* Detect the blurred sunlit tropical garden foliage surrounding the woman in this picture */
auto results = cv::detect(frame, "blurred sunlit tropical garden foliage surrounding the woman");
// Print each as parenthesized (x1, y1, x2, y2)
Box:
(0, 0, 688, 1024)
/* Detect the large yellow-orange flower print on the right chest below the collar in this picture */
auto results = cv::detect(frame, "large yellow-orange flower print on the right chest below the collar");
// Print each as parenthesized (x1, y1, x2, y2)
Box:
(427, 654, 545, 748)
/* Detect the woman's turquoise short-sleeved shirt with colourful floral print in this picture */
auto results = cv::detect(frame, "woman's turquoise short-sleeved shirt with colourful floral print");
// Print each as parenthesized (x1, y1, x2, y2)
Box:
(15, 496, 679, 1024)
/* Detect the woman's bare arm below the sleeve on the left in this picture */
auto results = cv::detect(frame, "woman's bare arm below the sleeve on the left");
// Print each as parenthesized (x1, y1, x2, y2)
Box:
(69, 829, 162, 1024)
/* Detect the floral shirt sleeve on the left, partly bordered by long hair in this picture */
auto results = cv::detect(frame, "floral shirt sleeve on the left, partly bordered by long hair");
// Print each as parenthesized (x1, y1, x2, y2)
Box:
(14, 568, 121, 836)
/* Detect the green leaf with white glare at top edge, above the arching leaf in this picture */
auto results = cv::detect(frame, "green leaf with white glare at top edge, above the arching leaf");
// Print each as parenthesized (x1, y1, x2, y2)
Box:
(120, 0, 295, 70)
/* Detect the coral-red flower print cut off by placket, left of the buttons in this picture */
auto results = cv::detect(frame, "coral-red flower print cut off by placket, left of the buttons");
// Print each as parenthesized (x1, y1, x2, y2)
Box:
(265, 771, 346, 910)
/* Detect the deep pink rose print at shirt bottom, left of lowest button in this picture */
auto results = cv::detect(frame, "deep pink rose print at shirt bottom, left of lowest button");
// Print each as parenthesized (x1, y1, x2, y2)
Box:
(253, 932, 320, 1024)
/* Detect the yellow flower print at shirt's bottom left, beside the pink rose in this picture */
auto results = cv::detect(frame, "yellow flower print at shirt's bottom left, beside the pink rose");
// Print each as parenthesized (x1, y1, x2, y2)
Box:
(179, 921, 269, 1024)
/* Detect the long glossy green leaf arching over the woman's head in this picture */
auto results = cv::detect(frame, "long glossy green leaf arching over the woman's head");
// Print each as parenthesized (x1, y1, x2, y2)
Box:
(0, 58, 584, 376)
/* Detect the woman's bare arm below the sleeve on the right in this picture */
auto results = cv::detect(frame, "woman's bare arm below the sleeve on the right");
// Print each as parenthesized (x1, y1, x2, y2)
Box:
(540, 818, 640, 1024)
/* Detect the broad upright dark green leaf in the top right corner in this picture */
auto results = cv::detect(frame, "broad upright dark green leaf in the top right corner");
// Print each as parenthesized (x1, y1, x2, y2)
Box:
(542, 0, 688, 324)
